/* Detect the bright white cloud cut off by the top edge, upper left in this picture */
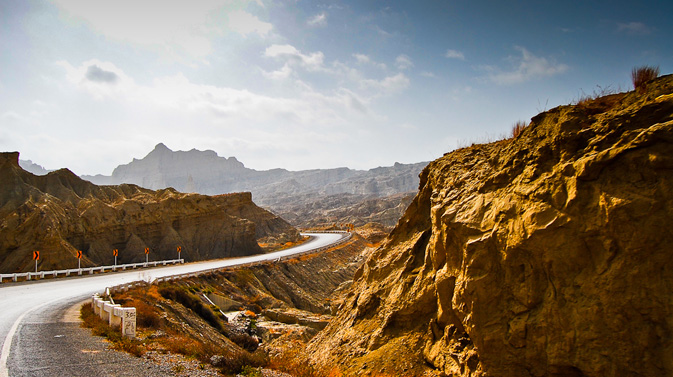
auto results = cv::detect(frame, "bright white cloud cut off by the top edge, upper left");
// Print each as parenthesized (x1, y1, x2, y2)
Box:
(53, 0, 273, 60)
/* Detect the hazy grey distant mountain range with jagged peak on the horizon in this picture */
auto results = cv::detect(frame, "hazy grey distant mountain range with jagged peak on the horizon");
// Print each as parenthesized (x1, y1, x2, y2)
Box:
(21, 143, 427, 226)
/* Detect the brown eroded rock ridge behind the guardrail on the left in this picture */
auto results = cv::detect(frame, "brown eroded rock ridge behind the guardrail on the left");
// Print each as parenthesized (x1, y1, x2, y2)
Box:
(0, 152, 299, 273)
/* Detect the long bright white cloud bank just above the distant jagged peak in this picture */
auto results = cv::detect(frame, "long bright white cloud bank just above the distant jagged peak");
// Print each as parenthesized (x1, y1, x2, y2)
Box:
(58, 60, 372, 126)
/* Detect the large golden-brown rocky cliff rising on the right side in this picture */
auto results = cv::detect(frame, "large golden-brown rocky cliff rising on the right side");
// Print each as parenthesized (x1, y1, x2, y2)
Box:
(309, 76, 673, 377)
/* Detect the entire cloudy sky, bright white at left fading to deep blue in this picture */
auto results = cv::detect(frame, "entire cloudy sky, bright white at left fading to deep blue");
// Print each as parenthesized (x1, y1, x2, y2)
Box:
(0, 0, 673, 175)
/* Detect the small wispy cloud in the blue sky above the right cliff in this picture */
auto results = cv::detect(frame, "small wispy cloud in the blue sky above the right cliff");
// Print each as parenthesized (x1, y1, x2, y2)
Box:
(481, 46, 568, 85)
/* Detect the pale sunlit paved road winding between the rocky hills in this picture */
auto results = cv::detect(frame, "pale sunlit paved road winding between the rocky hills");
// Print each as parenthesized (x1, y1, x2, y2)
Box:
(0, 233, 344, 377)
